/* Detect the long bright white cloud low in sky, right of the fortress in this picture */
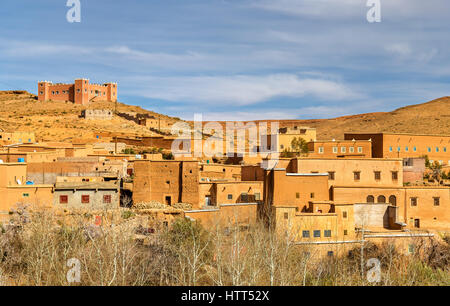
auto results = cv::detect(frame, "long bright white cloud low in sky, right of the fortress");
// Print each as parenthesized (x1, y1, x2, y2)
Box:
(127, 74, 360, 106)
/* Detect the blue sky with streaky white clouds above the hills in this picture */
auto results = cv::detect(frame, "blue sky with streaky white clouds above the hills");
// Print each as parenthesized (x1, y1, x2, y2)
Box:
(0, 0, 450, 120)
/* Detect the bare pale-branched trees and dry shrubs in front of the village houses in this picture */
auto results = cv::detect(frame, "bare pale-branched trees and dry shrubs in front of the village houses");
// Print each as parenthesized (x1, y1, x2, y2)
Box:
(0, 210, 450, 286)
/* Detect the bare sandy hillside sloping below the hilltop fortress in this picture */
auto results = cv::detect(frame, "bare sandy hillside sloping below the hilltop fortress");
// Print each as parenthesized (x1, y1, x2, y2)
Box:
(0, 91, 180, 141)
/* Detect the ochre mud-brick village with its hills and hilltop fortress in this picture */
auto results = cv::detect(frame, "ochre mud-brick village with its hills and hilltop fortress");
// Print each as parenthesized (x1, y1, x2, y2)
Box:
(0, 79, 450, 257)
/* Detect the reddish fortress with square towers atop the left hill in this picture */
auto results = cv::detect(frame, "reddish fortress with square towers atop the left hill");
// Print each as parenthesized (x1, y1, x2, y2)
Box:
(38, 79, 117, 105)
